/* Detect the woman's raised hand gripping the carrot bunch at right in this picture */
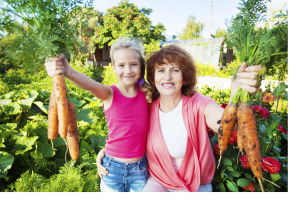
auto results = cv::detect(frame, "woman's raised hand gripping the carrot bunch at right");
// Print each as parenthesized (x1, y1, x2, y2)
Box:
(230, 62, 261, 102)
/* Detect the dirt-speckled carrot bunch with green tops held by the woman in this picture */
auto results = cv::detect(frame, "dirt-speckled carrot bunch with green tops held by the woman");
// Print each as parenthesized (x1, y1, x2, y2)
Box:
(218, 16, 287, 193)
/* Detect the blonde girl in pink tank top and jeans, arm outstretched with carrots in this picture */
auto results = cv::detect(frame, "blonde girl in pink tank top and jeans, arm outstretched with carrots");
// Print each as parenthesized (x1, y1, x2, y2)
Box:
(45, 37, 152, 193)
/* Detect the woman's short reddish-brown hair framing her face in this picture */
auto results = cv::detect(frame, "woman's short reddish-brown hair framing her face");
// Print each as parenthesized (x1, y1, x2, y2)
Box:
(146, 45, 197, 100)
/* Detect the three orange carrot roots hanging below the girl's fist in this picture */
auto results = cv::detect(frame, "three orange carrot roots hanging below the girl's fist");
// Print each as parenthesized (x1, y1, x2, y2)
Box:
(48, 75, 79, 161)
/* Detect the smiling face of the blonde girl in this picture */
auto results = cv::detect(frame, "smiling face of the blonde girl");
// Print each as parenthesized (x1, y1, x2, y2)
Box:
(113, 49, 141, 86)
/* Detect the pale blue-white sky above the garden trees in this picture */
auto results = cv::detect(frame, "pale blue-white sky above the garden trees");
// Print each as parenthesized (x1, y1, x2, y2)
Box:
(94, 0, 288, 39)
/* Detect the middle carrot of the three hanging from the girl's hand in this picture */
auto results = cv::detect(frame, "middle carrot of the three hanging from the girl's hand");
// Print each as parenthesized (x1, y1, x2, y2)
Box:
(52, 75, 68, 138)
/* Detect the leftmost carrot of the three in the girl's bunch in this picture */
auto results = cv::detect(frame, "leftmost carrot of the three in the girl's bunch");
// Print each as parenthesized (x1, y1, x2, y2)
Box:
(48, 90, 58, 141)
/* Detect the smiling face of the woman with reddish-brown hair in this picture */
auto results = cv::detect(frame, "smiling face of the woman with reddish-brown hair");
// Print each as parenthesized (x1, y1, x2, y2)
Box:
(154, 61, 184, 98)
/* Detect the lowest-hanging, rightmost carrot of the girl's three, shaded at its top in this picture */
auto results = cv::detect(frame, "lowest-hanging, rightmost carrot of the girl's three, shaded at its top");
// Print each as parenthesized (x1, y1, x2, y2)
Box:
(67, 101, 79, 161)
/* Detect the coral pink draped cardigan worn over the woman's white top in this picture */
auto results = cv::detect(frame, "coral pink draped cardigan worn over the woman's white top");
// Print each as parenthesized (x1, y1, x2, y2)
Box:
(146, 93, 215, 193)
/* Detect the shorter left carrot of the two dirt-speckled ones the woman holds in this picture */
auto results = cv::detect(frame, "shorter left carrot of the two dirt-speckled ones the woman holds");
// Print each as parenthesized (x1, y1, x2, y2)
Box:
(218, 102, 237, 167)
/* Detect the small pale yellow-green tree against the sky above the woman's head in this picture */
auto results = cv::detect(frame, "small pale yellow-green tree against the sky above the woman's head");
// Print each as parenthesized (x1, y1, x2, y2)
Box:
(178, 15, 204, 40)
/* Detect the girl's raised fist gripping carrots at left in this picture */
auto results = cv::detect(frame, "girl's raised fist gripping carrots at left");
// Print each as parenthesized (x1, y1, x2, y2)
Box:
(45, 54, 71, 77)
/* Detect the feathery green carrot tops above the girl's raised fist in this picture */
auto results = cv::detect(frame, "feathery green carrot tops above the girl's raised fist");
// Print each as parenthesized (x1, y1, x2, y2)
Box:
(0, 0, 92, 70)
